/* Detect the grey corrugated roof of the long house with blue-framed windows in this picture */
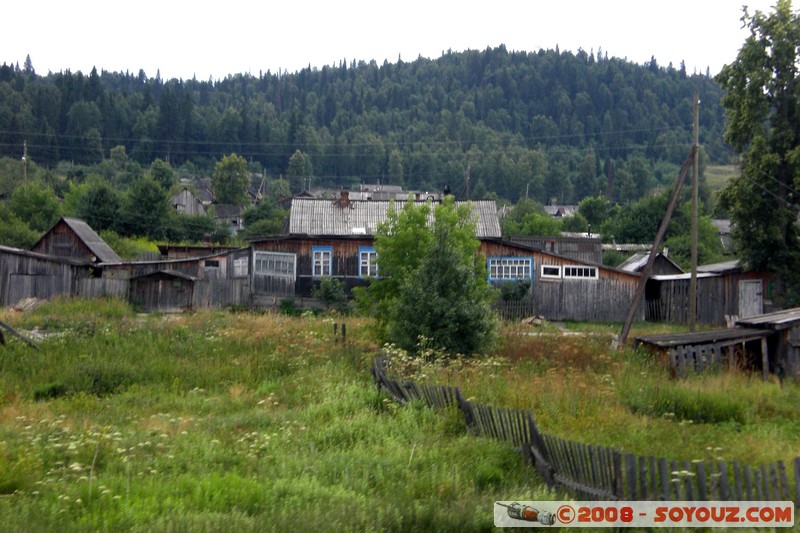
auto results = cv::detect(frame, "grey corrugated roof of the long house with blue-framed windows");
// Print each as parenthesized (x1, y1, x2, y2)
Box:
(289, 198, 501, 238)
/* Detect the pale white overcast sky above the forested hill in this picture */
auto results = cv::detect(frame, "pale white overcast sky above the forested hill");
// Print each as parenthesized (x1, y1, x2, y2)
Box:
(0, 0, 775, 80)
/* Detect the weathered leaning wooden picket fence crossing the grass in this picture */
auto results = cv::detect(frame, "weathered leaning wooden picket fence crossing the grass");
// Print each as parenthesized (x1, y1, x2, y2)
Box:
(372, 357, 800, 505)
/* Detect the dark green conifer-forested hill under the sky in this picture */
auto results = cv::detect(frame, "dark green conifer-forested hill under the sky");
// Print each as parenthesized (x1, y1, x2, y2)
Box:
(0, 46, 731, 203)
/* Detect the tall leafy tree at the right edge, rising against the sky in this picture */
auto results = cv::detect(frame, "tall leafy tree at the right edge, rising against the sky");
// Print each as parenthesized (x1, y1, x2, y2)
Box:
(717, 0, 800, 304)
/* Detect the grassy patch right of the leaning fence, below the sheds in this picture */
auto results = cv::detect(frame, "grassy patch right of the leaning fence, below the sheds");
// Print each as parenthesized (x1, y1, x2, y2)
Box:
(401, 325, 800, 465)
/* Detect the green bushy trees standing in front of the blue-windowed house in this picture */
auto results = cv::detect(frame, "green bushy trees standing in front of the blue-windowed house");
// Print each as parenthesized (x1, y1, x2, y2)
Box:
(365, 197, 496, 355)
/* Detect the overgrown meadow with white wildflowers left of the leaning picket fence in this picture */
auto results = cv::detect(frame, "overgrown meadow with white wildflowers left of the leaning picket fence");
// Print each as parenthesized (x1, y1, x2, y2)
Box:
(0, 301, 553, 532)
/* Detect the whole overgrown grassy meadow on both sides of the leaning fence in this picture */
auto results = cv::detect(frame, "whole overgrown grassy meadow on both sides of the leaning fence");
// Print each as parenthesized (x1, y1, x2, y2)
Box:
(0, 301, 800, 531)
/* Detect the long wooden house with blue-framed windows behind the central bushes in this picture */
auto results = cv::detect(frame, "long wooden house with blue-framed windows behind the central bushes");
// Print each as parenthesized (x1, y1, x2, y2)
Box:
(252, 192, 644, 321)
